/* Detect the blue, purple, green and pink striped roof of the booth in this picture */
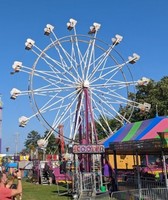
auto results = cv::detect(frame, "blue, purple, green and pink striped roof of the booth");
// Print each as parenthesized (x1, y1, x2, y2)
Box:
(102, 116, 168, 152)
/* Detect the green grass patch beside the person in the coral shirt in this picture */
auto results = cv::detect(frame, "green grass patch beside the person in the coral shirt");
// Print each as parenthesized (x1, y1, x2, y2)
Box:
(23, 181, 71, 200)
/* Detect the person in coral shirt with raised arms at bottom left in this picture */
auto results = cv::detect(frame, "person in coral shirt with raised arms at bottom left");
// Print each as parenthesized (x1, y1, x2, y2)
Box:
(0, 170, 22, 200)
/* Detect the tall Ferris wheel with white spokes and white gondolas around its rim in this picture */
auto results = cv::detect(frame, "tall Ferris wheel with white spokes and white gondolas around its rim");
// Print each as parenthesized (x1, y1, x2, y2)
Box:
(11, 19, 150, 145)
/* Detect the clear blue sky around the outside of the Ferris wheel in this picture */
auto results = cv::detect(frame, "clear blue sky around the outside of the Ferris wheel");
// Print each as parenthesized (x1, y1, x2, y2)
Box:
(0, 0, 168, 153)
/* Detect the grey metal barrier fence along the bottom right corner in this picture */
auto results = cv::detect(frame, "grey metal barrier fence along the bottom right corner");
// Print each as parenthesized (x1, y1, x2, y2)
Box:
(111, 188, 168, 200)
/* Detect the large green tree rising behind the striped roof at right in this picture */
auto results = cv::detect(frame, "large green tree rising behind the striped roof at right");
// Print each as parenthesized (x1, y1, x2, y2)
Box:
(131, 76, 168, 122)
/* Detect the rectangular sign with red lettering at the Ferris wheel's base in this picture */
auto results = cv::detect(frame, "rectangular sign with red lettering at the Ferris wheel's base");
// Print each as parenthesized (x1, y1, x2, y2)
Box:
(72, 144, 105, 154)
